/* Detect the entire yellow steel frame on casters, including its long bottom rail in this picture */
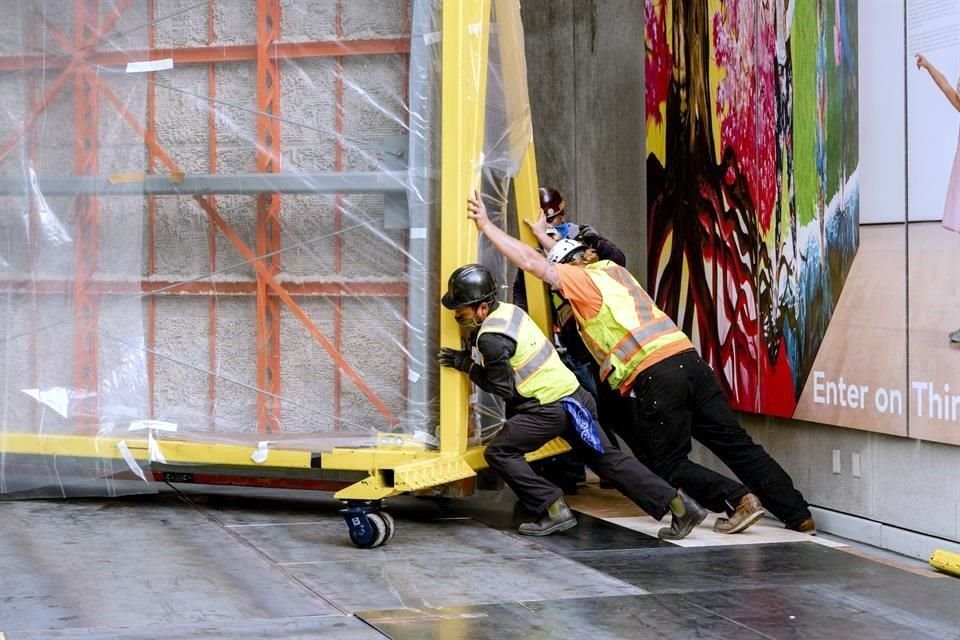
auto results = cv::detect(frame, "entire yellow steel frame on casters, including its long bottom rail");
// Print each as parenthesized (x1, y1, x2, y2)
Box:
(0, 0, 570, 500)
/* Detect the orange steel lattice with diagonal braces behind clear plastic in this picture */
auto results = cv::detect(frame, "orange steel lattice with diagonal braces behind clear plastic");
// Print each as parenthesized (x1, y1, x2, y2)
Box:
(0, 0, 410, 433)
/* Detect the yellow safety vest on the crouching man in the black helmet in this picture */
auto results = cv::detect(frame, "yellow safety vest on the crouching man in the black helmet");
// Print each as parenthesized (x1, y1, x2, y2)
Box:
(477, 302, 580, 404)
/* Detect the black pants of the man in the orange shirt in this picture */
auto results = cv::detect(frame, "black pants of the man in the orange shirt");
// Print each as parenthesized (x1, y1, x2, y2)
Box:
(619, 351, 810, 526)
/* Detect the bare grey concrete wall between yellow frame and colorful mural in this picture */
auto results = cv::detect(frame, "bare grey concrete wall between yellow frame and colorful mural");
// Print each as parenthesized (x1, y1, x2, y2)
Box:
(522, 0, 646, 282)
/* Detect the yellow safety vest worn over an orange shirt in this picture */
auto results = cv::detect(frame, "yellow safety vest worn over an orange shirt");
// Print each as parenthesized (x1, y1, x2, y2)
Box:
(573, 260, 693, 389)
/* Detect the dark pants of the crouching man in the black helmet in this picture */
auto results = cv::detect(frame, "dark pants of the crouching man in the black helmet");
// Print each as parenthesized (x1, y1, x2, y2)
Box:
(484, 387, 677, 520)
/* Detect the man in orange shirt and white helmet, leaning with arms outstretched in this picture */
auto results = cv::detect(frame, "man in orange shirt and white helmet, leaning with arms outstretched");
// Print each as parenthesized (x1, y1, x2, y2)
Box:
(467, 193, 815, 533)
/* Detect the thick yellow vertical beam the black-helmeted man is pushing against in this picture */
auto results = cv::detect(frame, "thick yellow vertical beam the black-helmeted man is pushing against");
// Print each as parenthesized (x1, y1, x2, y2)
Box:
(438, 0, 490, 454)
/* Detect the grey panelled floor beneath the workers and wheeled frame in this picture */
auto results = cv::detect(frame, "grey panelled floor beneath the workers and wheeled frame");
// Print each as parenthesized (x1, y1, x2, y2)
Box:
(0, 487, 960, 640)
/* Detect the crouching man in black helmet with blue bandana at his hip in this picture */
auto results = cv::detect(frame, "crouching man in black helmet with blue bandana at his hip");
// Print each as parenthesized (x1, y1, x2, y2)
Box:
(438, 264, 706, 540)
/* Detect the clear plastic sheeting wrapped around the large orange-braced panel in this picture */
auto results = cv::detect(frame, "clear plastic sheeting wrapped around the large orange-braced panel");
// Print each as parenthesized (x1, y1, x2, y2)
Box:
(0, 0, 531, 495)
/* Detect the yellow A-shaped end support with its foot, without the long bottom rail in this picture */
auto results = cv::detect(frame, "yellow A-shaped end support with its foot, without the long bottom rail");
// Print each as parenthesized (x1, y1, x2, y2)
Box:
(323, 0, 570, 500)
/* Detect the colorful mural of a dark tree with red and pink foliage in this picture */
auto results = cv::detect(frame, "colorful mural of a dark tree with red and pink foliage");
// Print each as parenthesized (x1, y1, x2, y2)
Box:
(645, 0, 859, 416)
